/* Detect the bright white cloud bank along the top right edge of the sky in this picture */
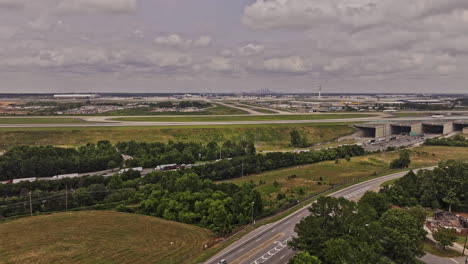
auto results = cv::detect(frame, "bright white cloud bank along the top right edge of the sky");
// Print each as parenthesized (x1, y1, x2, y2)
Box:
(242, 0, 468, 29)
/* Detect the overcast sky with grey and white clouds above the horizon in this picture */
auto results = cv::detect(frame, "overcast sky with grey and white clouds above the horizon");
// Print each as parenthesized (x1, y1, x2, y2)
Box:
(0, 0, 468, 93)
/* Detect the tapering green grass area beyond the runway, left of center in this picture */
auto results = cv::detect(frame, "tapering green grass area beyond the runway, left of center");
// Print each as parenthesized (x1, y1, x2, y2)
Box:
(98, 103, 248, 116)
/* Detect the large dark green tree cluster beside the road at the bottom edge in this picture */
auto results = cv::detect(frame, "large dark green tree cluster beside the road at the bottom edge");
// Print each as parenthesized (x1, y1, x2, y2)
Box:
(290, 194, 425, 264)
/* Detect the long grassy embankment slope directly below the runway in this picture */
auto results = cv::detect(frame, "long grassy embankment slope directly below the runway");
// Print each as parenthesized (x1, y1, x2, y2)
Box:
(0, 123, 355, 150)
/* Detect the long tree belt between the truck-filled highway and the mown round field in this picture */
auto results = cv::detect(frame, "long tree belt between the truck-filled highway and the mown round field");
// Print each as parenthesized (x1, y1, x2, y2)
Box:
(0, 168, 263, 234)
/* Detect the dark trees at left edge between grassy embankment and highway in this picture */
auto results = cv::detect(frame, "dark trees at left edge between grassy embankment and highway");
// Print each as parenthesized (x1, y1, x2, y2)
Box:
(0, 141, 122, 180)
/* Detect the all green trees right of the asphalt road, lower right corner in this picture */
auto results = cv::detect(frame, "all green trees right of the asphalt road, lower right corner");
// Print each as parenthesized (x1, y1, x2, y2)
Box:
(290, 161, 468, 264)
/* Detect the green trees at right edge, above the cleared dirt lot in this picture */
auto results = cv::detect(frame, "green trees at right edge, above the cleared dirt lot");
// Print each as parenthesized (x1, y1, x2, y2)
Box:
(382, 161, 468, 211)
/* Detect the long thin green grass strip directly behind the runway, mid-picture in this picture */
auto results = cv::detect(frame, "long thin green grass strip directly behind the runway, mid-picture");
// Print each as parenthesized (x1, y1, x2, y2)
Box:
(114, 114, 373, 122)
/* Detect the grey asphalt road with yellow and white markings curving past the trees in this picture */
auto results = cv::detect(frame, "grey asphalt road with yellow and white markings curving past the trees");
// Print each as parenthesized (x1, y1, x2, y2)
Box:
(206, 167, 434, 264)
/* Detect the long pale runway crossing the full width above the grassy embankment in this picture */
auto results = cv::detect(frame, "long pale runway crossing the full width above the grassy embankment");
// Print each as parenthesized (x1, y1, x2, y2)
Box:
(0, 115, 468, 128)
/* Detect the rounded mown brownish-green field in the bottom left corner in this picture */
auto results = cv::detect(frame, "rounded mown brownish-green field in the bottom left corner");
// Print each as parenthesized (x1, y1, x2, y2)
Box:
(0, 211, 214, 264)
